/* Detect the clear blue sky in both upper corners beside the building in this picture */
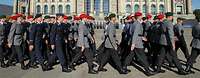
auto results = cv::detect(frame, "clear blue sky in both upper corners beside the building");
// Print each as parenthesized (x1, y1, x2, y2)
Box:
(0, 0, 200, 9)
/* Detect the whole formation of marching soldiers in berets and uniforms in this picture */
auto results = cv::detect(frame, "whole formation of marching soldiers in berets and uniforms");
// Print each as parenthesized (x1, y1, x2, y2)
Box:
(0, 12, 200, 76)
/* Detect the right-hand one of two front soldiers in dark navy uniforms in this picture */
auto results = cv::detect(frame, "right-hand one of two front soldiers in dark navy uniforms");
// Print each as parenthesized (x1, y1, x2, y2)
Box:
(50, 14, 71, 72)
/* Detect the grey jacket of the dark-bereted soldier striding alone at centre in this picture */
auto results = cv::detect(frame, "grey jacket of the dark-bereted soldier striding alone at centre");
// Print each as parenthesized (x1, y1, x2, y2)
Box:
(104, 22, 117, 48)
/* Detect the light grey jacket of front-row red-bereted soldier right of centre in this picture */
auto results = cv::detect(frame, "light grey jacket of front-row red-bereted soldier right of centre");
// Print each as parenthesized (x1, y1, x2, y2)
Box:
(132, 20, 144, 48)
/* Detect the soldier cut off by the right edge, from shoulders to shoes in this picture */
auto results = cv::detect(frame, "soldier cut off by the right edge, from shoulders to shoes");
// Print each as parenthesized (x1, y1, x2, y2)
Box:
(185, 20, 200, 73)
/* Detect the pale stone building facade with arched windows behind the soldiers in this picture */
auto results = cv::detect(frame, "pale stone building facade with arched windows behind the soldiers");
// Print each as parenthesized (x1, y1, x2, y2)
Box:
(13, 0, 192, 18)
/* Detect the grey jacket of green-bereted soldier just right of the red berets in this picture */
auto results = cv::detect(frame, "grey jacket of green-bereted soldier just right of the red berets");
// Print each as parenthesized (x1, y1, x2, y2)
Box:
(159, 20, 174, 46)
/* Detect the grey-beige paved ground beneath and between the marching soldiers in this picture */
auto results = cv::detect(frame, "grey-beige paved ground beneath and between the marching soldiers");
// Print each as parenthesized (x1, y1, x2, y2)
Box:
(0, 29, 200, 78)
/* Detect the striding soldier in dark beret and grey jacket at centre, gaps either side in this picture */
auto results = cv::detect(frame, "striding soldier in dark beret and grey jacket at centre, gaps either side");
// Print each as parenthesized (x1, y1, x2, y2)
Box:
(98, 13, 128, 74)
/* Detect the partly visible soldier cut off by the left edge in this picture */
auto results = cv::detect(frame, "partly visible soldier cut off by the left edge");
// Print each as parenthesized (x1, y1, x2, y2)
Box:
(0, 15, 7, 68)
